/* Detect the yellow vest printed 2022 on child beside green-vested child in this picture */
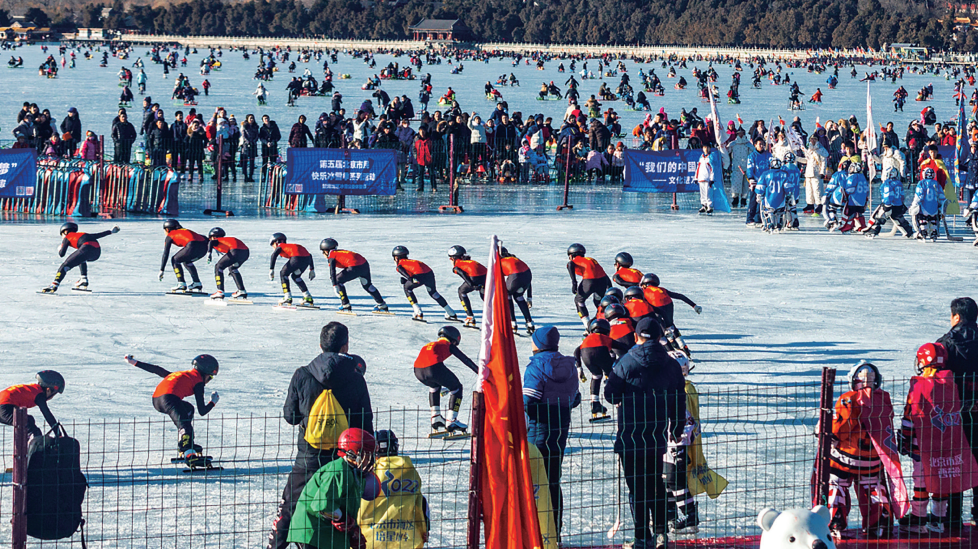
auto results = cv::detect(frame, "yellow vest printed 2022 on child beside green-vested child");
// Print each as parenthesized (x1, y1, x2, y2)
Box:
(357, 456, 428, 549)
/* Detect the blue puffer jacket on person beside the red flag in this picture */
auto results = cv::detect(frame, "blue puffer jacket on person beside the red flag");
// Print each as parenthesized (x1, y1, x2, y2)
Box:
(523, 351, 581, 447)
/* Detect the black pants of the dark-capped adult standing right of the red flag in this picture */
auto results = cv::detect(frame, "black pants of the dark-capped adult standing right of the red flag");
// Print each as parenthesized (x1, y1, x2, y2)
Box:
(618, 448, 667, 541)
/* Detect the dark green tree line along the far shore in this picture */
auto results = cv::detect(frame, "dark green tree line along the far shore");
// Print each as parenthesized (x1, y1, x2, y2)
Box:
(0, 0, 978, 52)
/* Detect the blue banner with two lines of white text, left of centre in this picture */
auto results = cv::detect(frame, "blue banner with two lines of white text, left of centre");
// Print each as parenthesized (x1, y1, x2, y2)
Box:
(285, 148, 397, 196)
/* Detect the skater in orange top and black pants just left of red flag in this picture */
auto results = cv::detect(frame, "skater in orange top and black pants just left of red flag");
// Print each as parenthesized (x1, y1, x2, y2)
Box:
(414, 326, 479, 437)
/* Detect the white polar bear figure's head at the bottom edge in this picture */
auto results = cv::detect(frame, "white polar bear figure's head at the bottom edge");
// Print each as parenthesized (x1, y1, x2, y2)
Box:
(757, 505, 835, 549)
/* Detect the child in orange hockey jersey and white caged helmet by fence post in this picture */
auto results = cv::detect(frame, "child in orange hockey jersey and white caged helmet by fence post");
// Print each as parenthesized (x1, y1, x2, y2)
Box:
(828, 362, 906, 539)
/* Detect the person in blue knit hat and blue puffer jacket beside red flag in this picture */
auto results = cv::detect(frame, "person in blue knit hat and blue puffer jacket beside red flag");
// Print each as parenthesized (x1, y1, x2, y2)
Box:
(523, 326, 576, 540)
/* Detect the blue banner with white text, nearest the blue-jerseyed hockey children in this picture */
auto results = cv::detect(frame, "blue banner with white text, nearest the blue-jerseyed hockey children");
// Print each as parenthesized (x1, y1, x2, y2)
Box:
(623, 149, 703, 193)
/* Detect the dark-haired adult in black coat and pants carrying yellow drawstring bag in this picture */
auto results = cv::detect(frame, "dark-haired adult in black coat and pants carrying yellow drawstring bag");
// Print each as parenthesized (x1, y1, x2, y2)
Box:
(267, 322, 374, 549)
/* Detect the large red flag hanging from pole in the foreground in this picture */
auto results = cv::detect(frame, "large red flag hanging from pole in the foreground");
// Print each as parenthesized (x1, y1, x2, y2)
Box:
(476, 236, 543, 549)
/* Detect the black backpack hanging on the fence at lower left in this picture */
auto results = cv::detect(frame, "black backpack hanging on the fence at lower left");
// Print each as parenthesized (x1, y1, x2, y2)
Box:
(26, 425, 88, 547)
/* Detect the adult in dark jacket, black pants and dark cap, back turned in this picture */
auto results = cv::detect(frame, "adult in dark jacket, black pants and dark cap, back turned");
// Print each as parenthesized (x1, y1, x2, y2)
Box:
(604, 318, 686, 547)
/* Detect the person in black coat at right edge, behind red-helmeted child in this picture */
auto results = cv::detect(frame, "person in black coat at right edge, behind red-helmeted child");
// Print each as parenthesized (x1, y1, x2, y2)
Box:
(937, 297, 978, 528)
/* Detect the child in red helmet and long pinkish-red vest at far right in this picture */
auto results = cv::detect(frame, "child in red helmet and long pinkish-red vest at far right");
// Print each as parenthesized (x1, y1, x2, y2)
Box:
(897, 343, 978, 532)
